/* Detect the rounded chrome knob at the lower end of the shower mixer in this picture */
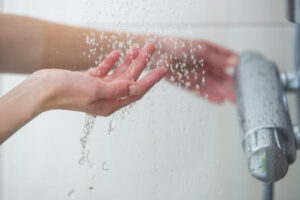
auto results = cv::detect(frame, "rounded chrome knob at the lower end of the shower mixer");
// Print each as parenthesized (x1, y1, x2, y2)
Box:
(244, 128, 289, 182)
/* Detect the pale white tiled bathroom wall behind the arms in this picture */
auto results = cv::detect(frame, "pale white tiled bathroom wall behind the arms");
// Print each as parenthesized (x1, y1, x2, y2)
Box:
(0, 0, 300, 200)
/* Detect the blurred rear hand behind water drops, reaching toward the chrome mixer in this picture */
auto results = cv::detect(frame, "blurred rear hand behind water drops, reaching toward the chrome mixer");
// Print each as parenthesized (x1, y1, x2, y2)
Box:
(155, 38, 238, 103)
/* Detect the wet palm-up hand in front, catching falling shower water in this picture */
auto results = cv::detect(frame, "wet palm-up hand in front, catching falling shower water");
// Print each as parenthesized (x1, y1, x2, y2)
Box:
(34, 44, 166, 116)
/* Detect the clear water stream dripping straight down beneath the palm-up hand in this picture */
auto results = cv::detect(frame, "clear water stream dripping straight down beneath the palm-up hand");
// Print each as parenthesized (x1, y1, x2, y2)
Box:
(79, 114, 96, 169)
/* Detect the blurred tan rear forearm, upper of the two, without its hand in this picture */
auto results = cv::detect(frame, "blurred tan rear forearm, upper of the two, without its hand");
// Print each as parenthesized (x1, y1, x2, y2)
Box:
(0, 14, 144, 73)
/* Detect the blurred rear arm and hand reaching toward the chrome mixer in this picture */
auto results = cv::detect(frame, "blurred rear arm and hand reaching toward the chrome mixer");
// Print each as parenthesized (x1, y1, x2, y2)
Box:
(0, 14, 238, 103)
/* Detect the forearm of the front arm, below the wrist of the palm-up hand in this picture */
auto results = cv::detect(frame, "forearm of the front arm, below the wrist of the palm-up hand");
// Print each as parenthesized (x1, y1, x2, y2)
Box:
(0, 73, 49, 144)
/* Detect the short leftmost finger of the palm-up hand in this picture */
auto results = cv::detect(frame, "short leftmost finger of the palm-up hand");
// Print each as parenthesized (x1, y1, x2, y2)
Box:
(88, 51, 120, 78)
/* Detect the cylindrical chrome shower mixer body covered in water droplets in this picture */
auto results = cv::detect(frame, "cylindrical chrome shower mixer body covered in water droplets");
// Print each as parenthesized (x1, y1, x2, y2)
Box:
(235, 52, 296, 182)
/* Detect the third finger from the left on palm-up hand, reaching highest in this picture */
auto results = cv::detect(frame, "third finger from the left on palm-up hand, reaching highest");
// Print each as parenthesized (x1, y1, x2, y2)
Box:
(123, 44, 155, 80)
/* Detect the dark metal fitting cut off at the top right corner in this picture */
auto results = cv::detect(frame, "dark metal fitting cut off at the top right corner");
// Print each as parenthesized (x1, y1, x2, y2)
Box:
(286, 0, 300, 23)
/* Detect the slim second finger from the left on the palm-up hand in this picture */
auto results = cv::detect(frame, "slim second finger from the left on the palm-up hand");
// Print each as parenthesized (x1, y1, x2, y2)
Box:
(105, 46, 140, 81)
